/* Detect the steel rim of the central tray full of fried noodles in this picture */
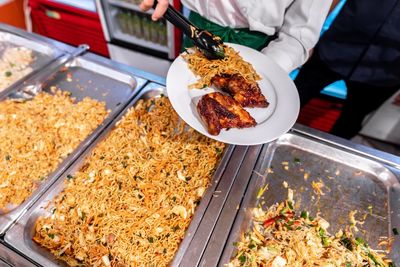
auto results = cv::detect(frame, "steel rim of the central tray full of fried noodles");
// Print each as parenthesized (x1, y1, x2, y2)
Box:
(4, 83, 246, 267)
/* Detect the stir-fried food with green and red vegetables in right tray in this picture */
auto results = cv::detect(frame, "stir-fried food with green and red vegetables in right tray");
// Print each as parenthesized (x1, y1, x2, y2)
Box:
(228, 200, 394, 267)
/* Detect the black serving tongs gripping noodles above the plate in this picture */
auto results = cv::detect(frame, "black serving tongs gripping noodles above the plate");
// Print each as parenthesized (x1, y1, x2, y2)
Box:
(153, 0, 225, 59)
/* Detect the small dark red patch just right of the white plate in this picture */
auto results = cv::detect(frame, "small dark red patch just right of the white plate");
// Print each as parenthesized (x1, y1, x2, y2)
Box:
(297, 98, 342, 132)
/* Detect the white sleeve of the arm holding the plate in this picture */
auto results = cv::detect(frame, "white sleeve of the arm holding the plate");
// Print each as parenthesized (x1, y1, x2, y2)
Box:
(262, 0, 332, 73)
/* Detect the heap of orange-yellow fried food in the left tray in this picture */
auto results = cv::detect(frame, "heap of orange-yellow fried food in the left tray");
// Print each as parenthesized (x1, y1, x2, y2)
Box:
(0, 90, 107, 212)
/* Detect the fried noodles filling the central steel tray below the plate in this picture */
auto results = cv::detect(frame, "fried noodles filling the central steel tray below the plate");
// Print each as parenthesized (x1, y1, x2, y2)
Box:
(34, 97, 224, 267)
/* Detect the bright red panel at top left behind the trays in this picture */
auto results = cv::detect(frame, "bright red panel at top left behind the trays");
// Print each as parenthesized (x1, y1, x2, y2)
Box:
(29, 0, 109, 57)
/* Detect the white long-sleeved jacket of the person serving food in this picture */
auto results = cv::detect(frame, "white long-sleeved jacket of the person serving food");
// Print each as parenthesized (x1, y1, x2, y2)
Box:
(182, 0, 332, 72)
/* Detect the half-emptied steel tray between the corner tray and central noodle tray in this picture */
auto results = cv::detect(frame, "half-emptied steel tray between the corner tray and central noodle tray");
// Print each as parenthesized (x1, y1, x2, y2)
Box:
(0, 51, 146, 234)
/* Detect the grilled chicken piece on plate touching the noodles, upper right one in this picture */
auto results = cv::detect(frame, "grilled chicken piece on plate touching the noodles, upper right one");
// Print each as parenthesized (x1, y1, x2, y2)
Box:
(211, 74, 269, 108)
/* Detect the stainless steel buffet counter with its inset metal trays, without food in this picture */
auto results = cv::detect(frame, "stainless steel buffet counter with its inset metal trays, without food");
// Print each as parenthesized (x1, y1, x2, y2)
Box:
(0, 24, 400, 267)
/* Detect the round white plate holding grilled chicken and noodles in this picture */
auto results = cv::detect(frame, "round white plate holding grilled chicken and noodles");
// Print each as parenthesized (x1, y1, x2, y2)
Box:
(167, 44, 300, 145)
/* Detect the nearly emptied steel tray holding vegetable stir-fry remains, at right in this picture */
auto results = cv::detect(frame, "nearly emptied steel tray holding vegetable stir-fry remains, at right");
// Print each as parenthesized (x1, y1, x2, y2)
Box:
(199, 131, 400, 266)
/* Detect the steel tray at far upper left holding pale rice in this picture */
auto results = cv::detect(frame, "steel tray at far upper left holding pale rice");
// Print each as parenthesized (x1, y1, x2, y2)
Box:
(0, 23, 67, 97)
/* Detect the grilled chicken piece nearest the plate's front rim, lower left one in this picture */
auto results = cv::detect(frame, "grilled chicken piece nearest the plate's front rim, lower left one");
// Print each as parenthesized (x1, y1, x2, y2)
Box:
(197, 92, 257, 135)
